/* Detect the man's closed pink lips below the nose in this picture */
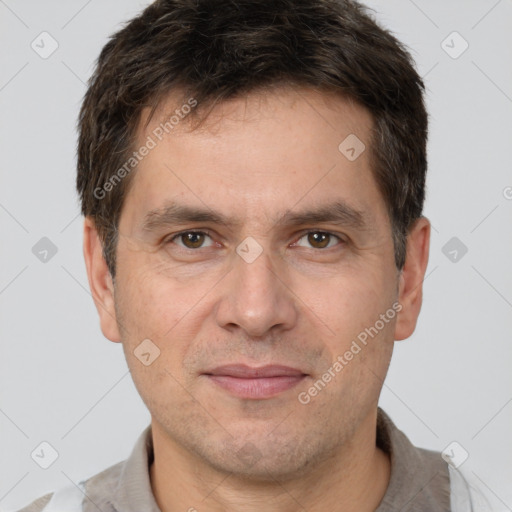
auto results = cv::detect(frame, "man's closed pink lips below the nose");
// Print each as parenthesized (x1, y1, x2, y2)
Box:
(203, 365, 307, 400)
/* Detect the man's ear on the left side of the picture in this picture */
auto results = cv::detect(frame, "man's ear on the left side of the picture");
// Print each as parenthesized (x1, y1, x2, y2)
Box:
(84, 217, 121, 342)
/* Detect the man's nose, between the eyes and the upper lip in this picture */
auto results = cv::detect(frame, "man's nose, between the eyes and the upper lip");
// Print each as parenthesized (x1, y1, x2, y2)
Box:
(216, 245, 298, 337)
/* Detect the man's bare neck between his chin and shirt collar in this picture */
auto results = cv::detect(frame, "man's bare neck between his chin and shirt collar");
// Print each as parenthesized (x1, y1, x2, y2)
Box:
(150, 411, 390, 512)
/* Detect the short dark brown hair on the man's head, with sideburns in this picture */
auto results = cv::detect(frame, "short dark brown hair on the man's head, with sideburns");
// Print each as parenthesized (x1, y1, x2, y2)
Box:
(77, 0, 427, 277)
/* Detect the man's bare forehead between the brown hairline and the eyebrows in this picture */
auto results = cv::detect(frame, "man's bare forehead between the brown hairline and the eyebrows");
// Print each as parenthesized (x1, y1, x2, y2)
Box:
(125, 88, 386, 234)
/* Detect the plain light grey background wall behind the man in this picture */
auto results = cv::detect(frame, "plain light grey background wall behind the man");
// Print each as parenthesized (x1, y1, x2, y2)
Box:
(0, 0, 512, 510)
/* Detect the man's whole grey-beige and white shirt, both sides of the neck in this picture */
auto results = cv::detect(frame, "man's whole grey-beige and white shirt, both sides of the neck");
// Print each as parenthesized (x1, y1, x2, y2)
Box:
(15, 409, 490, 512)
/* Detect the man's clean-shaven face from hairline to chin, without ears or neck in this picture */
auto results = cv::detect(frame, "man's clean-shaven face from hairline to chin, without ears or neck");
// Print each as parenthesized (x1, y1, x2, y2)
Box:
(96, 90, 398, 479)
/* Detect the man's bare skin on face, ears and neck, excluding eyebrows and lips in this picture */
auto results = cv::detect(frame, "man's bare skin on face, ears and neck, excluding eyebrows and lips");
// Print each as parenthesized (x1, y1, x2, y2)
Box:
(84, 89, 430, 512)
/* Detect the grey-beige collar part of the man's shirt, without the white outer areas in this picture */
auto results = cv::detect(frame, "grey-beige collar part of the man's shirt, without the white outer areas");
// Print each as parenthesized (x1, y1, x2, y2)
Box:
(84, 408, 450, 512)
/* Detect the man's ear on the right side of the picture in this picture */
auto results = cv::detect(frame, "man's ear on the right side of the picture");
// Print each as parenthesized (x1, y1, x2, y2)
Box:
(395, 217, 430, 340)
